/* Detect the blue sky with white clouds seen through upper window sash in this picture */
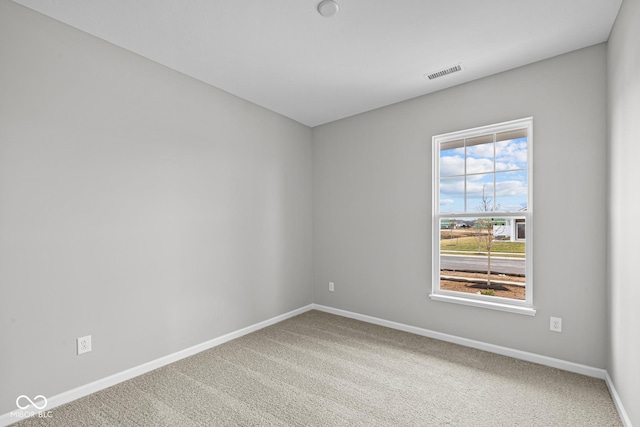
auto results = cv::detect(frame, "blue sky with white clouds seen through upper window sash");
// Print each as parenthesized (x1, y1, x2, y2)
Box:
(440, 137, 528, 213)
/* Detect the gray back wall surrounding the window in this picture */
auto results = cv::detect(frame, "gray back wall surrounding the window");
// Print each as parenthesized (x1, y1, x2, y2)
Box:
(313, 44, 607, 368)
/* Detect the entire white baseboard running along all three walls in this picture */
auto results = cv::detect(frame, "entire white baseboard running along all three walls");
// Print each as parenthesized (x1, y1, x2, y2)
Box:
(0, 304, 632, 427)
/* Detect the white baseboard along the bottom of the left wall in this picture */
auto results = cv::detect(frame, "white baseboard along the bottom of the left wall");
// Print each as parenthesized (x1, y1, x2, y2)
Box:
(0, 304, 312, 427)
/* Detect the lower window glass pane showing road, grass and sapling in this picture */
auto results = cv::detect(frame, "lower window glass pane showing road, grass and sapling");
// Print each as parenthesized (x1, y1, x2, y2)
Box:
(440, 217, 526, 300)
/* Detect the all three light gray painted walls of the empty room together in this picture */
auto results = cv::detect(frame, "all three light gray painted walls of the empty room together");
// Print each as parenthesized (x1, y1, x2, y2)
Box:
(0, 0, 640, 424)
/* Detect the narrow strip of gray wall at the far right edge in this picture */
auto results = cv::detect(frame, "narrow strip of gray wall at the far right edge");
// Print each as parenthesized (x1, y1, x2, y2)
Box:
(607, 0, 640, 426)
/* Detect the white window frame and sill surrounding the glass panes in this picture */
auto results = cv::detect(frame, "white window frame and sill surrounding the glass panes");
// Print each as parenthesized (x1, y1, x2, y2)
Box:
(429, 117, 536, 316)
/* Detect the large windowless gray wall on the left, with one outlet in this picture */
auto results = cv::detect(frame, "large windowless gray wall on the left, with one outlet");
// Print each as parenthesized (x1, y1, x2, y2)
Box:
(0, 0, 312, 414)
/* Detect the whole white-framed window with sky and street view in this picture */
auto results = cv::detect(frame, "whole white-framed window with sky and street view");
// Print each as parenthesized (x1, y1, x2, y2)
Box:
(430, 118, 535, 315)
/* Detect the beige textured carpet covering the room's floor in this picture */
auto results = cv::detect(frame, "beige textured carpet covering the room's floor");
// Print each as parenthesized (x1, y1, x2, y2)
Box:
(18, 311, 622, 427)
